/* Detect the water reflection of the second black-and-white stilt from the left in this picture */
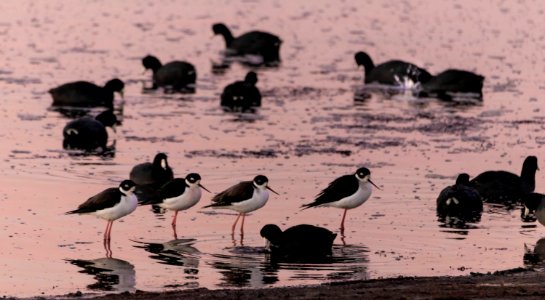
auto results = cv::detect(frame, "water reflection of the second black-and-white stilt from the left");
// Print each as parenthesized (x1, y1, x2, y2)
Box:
(133, 239, 200, 282)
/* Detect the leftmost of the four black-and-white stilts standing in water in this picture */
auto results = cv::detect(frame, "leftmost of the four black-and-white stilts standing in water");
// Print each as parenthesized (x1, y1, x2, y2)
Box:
(66, 180, 138, 241)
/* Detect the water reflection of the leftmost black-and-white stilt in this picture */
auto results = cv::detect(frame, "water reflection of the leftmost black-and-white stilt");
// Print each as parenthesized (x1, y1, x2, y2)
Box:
(66, 257, 136, 292)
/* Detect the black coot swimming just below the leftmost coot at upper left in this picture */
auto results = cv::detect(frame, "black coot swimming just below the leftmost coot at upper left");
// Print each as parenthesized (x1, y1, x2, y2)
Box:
(62, 110, 117, 151)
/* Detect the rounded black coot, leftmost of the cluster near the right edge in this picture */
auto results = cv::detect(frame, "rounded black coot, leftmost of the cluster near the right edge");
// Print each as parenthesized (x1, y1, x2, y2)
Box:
(437, 173, 483, 219)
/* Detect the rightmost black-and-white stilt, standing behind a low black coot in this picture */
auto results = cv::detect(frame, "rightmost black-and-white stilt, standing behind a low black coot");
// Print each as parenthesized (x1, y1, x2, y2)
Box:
(301, 168, 379, 233)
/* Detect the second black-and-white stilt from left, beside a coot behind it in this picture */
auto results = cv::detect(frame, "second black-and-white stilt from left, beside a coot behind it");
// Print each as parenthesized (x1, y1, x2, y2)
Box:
(142, 173, 210, 236)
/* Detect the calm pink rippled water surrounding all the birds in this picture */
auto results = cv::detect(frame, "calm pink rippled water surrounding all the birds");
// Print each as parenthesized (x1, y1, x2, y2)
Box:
(0, 0, 545, 296)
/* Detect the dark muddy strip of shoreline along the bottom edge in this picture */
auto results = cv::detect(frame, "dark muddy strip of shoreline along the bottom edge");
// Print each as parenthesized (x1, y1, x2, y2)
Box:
(67, 268, 545, 300)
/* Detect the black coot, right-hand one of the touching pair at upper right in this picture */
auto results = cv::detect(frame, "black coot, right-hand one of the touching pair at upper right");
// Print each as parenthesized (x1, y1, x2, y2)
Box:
(419, 69, 484, 100)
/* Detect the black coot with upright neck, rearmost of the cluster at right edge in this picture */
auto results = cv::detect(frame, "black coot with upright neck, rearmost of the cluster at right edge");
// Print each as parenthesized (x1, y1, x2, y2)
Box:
(470, 156, 539, 205)
